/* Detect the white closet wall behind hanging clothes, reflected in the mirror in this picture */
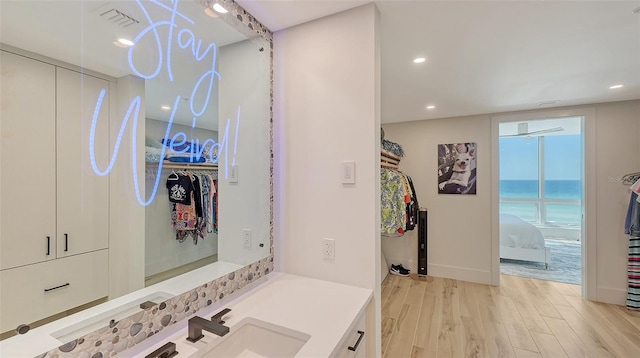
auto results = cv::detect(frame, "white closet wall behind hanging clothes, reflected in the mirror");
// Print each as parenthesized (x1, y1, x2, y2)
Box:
(144, 118, 218, 277)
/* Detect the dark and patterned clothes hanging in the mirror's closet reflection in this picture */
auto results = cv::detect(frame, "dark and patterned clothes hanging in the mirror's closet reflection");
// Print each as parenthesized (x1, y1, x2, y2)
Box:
(166, 171, 217, 244)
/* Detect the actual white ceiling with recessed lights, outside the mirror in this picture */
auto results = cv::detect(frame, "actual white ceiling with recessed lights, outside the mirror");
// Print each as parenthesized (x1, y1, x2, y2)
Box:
(236, 0, 640, 123)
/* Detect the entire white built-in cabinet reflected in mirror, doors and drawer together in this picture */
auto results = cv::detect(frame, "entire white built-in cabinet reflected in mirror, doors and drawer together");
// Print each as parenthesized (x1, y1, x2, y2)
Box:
(0, 50, 110, 332)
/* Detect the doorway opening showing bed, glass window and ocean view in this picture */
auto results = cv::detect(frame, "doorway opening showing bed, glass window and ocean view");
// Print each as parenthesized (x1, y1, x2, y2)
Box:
(499, 116, 584, 285)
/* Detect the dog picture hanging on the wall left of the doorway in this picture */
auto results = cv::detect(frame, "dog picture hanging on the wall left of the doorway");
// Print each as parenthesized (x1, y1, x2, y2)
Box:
(438, 143, 478, 195)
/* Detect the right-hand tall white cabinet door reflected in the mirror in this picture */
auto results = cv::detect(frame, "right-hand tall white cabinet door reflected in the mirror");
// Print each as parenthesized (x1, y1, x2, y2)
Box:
(56, 67, 111, 257)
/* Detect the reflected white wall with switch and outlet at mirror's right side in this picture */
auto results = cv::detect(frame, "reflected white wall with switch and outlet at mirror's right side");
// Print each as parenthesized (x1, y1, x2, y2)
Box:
(218, 39, 271, 265)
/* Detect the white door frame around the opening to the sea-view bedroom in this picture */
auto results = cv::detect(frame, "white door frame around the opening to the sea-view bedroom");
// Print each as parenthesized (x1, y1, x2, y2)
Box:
(491, 107, 598, 300)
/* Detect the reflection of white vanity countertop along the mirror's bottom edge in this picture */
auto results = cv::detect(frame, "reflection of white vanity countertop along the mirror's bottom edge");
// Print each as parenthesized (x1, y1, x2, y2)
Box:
(0, 261, 242, 358)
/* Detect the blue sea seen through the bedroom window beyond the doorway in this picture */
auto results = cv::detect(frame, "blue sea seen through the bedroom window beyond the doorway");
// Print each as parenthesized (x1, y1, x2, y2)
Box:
(500, 180, 582, 225)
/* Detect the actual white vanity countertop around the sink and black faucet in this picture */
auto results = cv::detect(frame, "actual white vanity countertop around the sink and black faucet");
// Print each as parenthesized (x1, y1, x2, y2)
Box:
(123, 272, 373, 358)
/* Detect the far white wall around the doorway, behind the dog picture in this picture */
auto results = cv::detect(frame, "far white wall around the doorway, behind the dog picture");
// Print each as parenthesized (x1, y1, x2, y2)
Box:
(383, 101, 640, 304)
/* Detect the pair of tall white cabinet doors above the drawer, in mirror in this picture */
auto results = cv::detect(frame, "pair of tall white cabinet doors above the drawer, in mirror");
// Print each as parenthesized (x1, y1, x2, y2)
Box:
(0, 51, 109, 269)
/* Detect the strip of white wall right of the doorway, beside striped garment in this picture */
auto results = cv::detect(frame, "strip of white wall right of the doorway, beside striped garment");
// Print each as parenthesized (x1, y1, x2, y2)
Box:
(595, 101, 640, 304)
